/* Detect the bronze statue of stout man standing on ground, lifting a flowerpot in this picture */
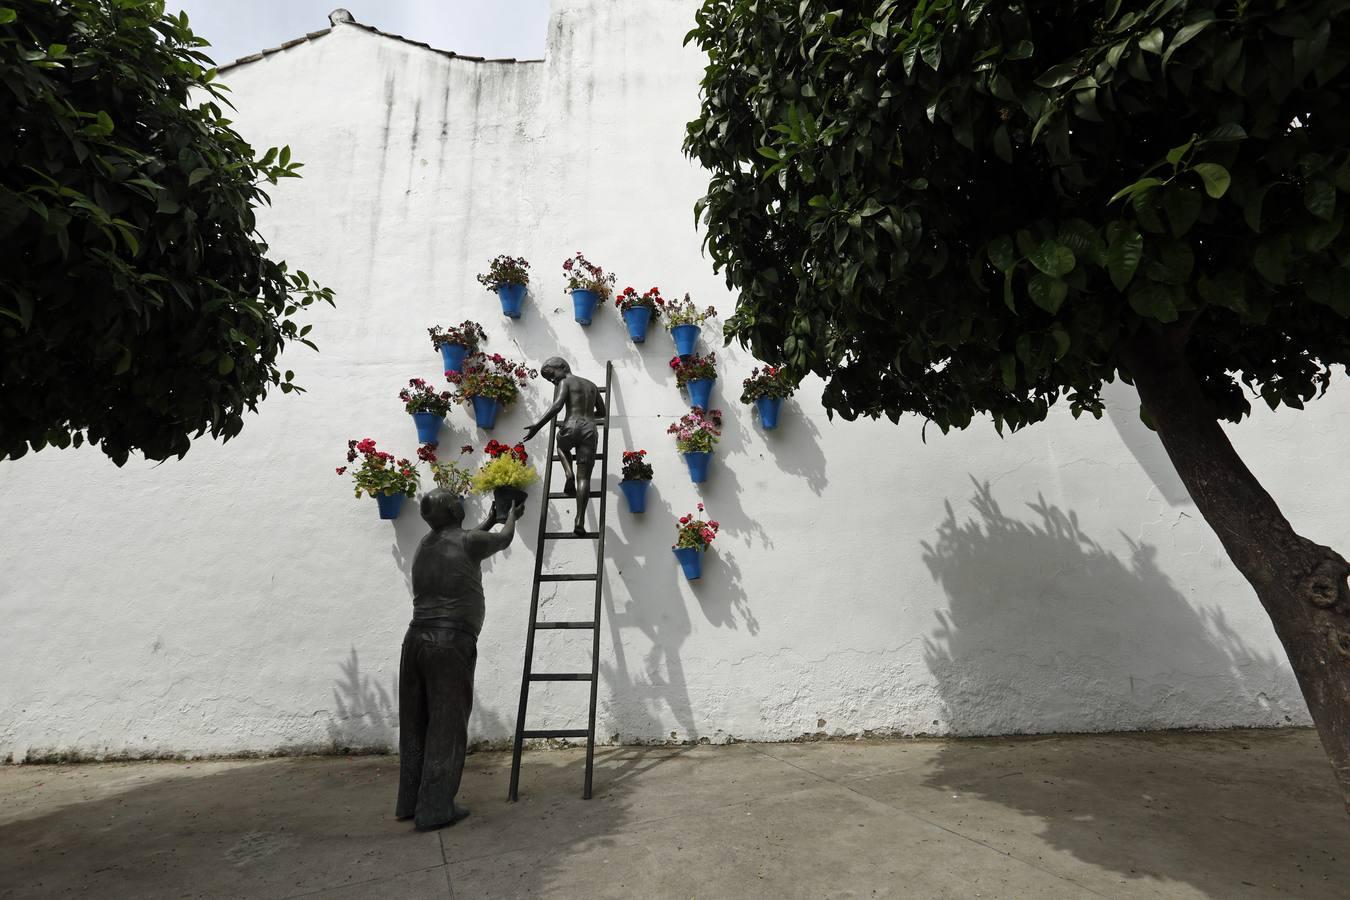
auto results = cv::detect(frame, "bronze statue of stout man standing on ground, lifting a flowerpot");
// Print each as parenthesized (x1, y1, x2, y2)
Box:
(394, 488, 520, 831)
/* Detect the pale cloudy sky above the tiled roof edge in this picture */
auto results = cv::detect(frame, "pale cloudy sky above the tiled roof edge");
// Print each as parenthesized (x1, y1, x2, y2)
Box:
(165, 0, 548, 63)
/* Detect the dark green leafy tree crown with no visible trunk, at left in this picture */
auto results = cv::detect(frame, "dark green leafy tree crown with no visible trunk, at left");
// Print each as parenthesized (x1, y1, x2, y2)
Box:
(0, 0, 332, 466)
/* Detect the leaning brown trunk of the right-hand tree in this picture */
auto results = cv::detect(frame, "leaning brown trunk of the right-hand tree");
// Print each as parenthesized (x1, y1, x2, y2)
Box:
(1125, 328, 1350, 812)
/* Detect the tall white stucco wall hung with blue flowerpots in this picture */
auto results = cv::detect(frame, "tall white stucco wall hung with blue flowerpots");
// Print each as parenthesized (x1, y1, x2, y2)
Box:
(0, 0, 1350, 761)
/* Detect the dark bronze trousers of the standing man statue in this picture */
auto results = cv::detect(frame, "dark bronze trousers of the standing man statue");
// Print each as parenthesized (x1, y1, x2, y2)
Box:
(394, 623, 478, 828)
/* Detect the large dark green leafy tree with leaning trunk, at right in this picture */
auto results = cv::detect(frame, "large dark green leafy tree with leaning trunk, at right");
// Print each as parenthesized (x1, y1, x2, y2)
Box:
(686, 0, 1350, 801)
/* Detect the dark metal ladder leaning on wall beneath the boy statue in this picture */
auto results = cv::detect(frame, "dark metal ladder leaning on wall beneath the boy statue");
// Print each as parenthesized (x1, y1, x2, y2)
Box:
(509, 363, 614, 800)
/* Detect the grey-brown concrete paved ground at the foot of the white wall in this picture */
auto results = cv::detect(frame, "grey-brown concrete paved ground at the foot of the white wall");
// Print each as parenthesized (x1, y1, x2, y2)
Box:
(0, 730, 1350, 900)
